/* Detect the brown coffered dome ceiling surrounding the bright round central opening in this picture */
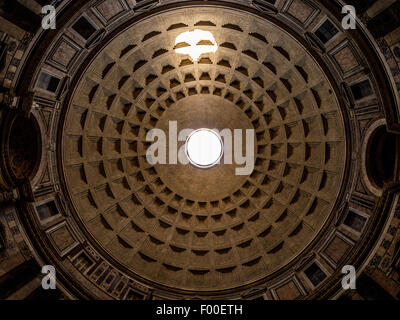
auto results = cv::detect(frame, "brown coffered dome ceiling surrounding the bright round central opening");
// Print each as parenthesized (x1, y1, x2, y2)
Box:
(62, 8, 346, 291)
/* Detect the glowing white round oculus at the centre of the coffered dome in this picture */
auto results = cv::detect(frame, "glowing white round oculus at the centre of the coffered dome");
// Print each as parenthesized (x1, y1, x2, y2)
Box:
(186, 129, 223, 168)
